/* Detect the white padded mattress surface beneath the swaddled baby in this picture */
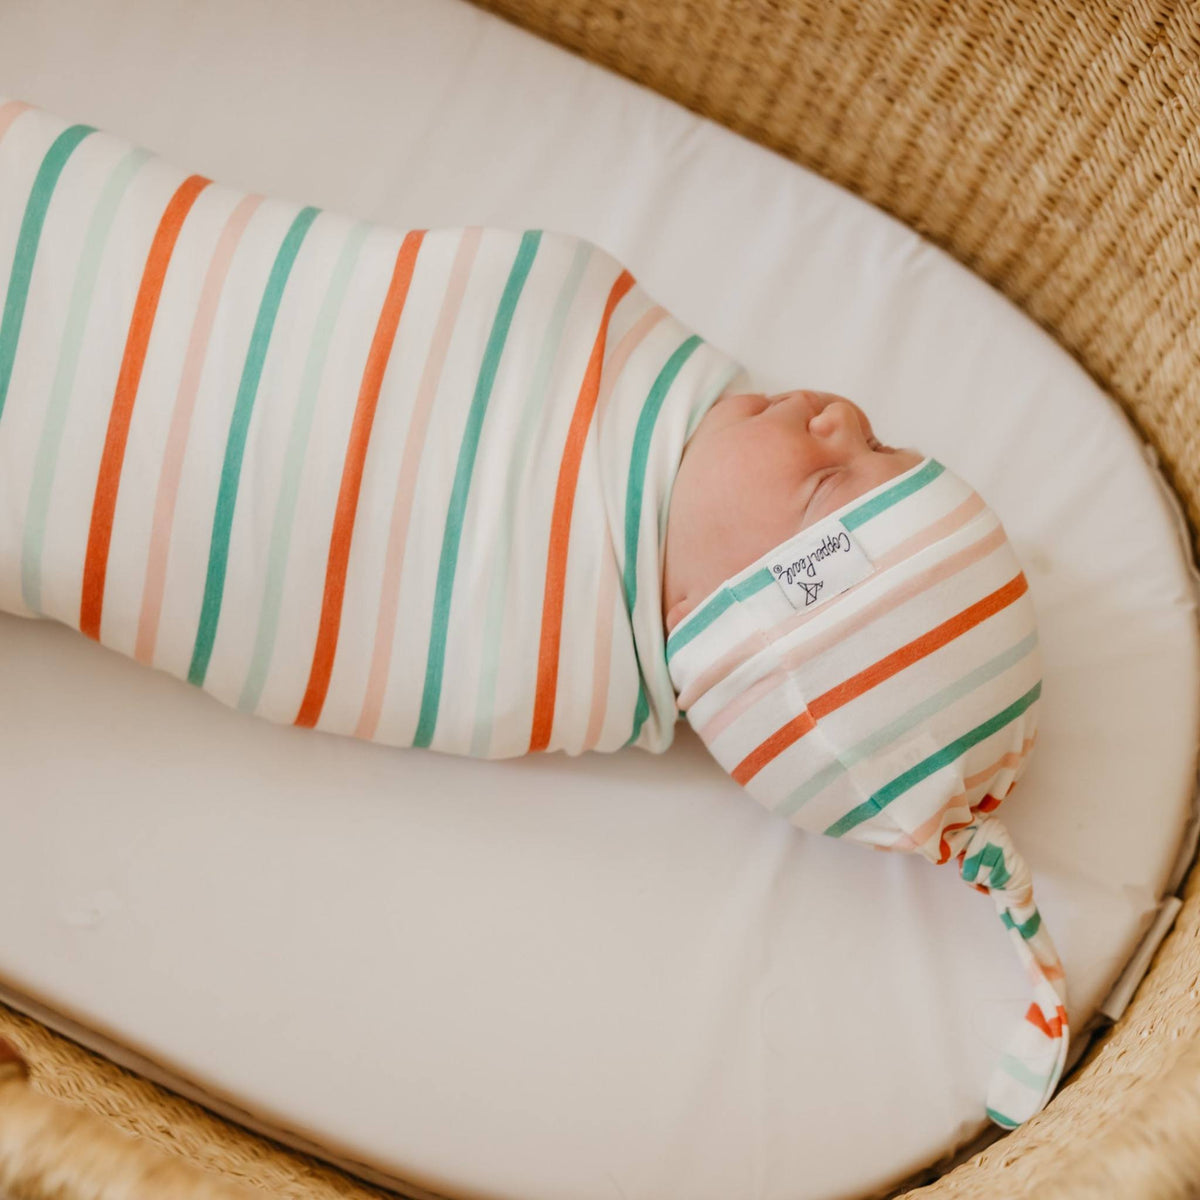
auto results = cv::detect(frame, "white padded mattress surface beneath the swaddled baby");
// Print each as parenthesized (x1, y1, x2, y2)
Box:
(0, 0, 1200, 1200)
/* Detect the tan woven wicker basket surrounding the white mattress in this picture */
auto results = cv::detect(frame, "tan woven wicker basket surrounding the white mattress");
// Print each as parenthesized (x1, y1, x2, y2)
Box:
(0, 0, 1200, 1200)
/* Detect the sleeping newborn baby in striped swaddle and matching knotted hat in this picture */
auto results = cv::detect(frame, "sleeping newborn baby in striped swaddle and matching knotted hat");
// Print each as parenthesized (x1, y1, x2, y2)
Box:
(0, 97, 1068, 1128)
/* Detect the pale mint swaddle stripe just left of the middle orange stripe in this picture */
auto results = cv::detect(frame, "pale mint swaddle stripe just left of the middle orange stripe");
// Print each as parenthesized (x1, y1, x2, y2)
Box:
(238, 221, 371, 713)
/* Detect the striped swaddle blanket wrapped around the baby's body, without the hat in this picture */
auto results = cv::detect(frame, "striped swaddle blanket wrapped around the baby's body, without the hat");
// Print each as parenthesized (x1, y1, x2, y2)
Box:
(0, 97, 742, 757)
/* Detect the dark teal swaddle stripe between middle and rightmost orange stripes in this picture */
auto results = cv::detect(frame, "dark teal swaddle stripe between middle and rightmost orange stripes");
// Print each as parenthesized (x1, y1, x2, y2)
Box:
(413, 229, 541, 746)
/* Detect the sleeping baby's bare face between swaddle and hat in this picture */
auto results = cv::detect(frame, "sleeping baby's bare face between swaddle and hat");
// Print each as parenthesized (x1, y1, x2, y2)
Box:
(662, 391, 924, 634)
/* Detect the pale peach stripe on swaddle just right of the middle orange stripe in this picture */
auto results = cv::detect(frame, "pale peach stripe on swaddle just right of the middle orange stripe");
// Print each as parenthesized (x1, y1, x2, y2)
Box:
(354, 226, 484, 739)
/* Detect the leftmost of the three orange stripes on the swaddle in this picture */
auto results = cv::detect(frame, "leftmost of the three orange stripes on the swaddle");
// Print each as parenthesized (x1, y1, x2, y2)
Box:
(79, 175, 212, 641)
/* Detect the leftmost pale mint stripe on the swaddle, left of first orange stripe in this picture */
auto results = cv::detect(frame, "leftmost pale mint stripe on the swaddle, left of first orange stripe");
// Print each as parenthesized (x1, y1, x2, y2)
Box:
(20, 146, 152, 613)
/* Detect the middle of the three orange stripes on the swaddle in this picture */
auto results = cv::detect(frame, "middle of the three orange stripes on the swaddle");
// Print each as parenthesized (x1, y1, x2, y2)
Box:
(295, 229, 426, 727)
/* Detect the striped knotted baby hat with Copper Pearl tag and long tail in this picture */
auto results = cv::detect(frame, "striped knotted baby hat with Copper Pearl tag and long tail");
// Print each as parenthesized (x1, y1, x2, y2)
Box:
(667, 458, 1069, 1129)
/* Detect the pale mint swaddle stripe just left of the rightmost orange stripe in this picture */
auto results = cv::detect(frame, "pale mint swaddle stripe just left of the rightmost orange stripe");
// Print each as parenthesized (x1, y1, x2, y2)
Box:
(470, 240, 595, 758)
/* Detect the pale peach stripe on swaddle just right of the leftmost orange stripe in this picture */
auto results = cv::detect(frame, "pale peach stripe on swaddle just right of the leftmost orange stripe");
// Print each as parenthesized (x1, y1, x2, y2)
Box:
(133, 193, 265, 665)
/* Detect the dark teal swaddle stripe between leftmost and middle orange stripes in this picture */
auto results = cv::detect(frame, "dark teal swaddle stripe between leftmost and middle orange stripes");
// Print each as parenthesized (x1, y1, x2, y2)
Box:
(187, 205, 320, 686)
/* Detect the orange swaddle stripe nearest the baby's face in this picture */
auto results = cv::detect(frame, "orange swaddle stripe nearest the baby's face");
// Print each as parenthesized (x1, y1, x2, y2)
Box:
(529, 271, 634, 754)
